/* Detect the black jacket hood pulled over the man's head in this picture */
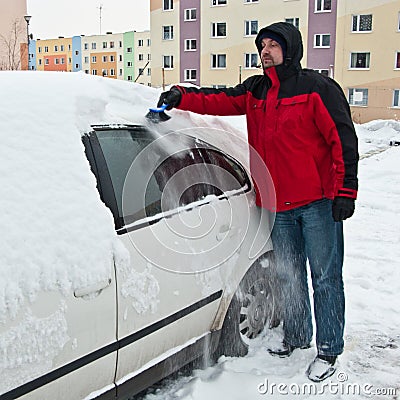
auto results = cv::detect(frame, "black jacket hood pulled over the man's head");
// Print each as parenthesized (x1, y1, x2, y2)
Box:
(256, 22, 303, 78)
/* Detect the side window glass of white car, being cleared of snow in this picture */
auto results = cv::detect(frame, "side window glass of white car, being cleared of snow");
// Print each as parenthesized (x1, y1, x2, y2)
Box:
(90, 128, 248, 225)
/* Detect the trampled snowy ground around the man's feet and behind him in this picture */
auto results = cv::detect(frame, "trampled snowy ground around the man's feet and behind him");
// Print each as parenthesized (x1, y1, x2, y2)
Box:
(135, 120, 400, 400)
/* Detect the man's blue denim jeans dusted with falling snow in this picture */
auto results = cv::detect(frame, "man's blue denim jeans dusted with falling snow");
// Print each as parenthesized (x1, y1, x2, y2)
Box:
(272, 199, 344, 356)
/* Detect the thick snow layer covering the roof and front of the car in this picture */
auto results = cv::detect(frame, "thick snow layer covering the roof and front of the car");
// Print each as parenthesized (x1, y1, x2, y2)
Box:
(0, 71, 246, 323)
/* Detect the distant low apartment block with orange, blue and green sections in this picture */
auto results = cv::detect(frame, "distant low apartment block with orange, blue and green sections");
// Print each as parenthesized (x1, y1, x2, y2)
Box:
(29, 31, 151, 86)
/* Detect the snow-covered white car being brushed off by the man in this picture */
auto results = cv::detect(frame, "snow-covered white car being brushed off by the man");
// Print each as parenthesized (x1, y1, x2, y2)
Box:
(0, 72, 279, 400)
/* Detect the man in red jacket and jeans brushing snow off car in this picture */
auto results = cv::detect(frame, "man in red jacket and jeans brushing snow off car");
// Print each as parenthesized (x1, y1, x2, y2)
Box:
(159, 22, 358, 381)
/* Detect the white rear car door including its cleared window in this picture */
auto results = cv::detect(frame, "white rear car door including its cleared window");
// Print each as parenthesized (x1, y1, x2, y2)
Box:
(85, 128, 253, 390)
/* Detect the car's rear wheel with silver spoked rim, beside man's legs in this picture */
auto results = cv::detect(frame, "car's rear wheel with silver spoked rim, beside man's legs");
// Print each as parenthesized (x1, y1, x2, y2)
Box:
(215, 252, 280, 358)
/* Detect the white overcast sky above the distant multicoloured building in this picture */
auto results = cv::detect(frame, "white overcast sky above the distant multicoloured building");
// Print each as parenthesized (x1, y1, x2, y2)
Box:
(27, 0, 150, 39)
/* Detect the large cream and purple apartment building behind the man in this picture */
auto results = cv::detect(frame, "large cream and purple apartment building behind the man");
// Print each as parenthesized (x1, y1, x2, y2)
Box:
(150, 0, 400, 123)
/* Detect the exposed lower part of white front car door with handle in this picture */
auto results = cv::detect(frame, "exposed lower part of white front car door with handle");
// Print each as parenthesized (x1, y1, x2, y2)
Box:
(0, 266, 117, 400)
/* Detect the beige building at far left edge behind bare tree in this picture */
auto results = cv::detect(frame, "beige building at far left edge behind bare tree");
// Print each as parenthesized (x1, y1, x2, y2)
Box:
(0, 0, 28, 70)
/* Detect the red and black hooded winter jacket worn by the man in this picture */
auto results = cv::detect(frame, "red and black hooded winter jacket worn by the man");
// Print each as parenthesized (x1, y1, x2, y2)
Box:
(173, 23, 358, 211)
